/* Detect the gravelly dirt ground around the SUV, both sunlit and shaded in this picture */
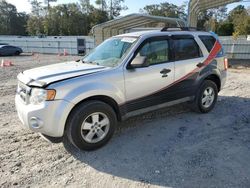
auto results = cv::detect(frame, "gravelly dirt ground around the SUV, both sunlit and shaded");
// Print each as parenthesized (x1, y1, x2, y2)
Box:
(0, 54, 250, 188)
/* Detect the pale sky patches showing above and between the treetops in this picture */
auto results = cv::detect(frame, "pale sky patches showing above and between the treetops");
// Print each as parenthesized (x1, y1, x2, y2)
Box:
(7, 0, 250, 16)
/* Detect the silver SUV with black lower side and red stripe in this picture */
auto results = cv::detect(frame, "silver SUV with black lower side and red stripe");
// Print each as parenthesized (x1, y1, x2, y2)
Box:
(15, 28, 227, 150)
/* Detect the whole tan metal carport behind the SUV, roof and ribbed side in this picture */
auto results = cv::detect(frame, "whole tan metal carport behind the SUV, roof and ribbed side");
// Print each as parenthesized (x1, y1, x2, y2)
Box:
(92, 14, 186, 44)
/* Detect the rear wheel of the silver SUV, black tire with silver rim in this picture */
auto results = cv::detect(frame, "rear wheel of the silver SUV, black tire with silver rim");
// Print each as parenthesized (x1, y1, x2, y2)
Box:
(191, 80, 218, 113)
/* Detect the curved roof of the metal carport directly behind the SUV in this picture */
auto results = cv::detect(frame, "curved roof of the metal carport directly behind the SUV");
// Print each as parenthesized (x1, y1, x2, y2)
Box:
(92, 14, 186, 32)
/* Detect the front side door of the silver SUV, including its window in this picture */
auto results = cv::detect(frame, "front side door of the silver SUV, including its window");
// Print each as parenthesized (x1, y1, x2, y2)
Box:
(124, 36, 174, 112)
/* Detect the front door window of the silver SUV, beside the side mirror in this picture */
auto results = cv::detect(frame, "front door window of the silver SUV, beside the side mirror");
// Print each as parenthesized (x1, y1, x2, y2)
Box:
(137, 39, 169, 65)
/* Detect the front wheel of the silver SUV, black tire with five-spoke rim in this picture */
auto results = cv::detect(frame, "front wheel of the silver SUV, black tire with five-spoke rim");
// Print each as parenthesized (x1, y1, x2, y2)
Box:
(63, 101, 117, 151)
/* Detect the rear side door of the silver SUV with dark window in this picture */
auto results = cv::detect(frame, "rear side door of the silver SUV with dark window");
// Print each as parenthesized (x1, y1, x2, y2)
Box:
(171, 35, 205, 98)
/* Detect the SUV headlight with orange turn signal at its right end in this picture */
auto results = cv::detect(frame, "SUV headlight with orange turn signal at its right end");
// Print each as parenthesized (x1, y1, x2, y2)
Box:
(30, 88, 56, 105)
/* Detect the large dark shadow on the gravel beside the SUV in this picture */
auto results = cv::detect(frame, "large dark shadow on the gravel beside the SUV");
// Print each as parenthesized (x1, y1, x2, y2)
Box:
(65, 96, 250, 187)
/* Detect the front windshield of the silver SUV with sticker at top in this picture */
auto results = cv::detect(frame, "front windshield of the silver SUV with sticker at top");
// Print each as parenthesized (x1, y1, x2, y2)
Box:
(83, 37, 137, 67)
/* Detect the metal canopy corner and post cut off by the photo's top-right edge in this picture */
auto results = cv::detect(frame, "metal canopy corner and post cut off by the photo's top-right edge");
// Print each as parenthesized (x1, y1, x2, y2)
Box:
(188, 0, 240, 27)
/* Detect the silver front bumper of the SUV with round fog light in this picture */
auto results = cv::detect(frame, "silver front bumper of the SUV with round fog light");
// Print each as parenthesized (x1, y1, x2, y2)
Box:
(15, 95, 74, 137)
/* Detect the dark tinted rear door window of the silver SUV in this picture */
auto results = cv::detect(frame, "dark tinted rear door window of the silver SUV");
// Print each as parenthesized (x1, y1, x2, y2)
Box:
(174, 38, 202, 61)
